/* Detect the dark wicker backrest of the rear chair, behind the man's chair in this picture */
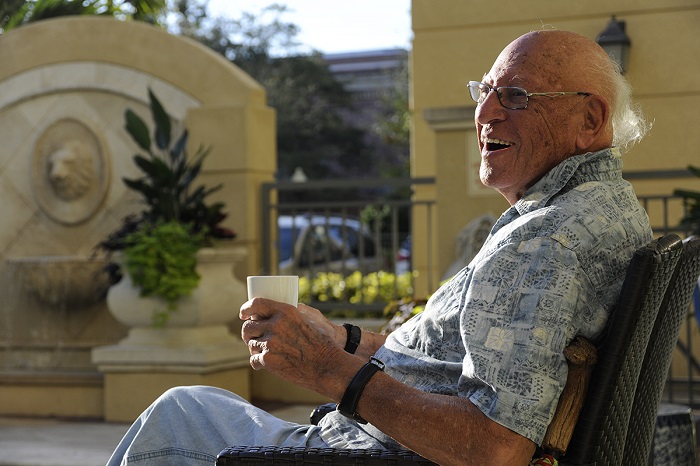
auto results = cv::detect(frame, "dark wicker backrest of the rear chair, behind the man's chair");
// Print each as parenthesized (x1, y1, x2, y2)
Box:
(624, 237, 700, 465)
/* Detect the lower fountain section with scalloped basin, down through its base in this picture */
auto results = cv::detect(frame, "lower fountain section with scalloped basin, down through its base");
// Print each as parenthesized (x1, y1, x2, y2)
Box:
(0, 256, 126, 417)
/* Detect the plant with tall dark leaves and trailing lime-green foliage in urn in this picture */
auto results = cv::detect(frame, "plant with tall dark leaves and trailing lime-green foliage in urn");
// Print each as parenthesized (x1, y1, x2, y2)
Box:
(99, 89, 240, 326)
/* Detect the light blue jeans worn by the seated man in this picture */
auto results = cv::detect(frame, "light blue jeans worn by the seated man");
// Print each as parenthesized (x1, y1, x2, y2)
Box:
(107, 386, 327, 466)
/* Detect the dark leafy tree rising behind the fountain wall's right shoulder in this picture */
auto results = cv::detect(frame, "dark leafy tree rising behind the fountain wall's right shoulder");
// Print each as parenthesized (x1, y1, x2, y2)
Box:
(177, 0, 373, 179)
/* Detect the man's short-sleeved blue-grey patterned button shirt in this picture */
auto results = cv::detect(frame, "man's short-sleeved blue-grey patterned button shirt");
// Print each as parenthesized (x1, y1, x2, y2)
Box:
(322, 148, 652, 447)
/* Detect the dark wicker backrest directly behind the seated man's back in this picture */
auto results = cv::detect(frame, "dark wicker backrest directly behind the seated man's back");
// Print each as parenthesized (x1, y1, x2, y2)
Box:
(560, 234, 683, 465)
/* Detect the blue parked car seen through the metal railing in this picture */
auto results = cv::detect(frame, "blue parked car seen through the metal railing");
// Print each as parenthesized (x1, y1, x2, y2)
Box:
(277, 215, 381, 276)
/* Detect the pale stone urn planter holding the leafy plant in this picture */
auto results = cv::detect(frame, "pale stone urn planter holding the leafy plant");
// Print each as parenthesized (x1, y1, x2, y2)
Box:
(107, 247, 247, 328)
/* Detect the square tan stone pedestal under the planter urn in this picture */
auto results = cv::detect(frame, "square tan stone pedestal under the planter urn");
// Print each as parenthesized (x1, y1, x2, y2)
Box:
(92, 325, 251, 422)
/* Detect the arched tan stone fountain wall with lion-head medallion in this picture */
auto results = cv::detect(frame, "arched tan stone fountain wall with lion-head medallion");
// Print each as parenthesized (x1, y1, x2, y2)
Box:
(0, 17, 276, 418)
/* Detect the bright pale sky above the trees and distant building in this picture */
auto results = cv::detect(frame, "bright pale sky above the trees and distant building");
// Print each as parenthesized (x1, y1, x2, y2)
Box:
(209, 0, 413, 53)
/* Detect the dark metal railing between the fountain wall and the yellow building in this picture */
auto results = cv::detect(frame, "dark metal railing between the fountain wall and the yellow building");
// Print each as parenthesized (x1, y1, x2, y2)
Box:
(261, 177, 435, 316)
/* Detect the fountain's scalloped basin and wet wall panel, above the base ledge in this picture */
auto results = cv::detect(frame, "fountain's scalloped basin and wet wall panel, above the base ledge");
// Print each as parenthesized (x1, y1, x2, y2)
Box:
(0, 256, 126, 373)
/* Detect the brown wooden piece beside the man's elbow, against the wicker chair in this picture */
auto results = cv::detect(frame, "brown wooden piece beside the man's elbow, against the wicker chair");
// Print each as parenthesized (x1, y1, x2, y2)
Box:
(541, 336, 598, 457)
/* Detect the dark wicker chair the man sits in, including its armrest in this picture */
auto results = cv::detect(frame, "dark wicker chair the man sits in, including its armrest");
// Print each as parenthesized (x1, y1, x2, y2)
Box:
(216, 234, 683, 466)
